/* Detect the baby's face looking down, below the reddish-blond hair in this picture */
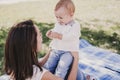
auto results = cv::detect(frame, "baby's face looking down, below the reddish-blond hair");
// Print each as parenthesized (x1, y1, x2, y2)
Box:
(55, 7, 72, 25)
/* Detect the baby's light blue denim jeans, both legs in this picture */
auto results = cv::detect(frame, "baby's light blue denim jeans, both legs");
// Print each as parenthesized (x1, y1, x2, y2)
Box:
(44, 50, 73, 79)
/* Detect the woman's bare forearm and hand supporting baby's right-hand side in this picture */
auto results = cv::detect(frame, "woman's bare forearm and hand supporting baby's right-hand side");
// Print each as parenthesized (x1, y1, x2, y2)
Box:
(68, 52, 79, 80)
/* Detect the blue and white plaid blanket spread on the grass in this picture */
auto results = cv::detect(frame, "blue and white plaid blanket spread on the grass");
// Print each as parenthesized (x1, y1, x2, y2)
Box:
(79, 39, 120, 80)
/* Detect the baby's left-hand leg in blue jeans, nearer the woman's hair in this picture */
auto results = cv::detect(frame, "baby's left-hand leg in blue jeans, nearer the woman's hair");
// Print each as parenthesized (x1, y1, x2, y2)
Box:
(44, 50, 61, 73)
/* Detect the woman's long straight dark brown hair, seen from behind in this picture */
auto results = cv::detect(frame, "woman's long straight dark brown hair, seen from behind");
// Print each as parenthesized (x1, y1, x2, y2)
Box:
(5, 20, 42, 80)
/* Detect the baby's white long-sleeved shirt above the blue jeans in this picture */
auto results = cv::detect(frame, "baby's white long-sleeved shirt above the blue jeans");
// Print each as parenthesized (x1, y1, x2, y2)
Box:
(50, 21, 81, 51)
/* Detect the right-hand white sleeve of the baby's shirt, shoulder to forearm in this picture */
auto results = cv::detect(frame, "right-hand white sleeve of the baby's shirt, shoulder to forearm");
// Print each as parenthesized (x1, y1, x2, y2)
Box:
(62, 23, 81, 41)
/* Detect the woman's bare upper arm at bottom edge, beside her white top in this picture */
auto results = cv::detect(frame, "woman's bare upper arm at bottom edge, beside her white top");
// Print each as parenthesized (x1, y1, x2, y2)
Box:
(42, 71, 63, 80)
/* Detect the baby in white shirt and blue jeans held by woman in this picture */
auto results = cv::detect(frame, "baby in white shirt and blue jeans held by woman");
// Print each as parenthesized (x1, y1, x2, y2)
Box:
(44, 0, 80, 79)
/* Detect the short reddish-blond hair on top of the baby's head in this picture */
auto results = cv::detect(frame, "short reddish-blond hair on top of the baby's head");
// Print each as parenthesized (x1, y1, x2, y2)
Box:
(55, 0, 75, 13)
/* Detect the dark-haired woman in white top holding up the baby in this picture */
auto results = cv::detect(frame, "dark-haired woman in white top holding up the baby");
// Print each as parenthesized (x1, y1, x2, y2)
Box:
(5, 20, 78, 80)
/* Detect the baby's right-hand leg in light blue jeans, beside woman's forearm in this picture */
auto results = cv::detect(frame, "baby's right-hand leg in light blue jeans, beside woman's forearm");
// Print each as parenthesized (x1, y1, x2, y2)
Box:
(55, 52, 73, 79)
